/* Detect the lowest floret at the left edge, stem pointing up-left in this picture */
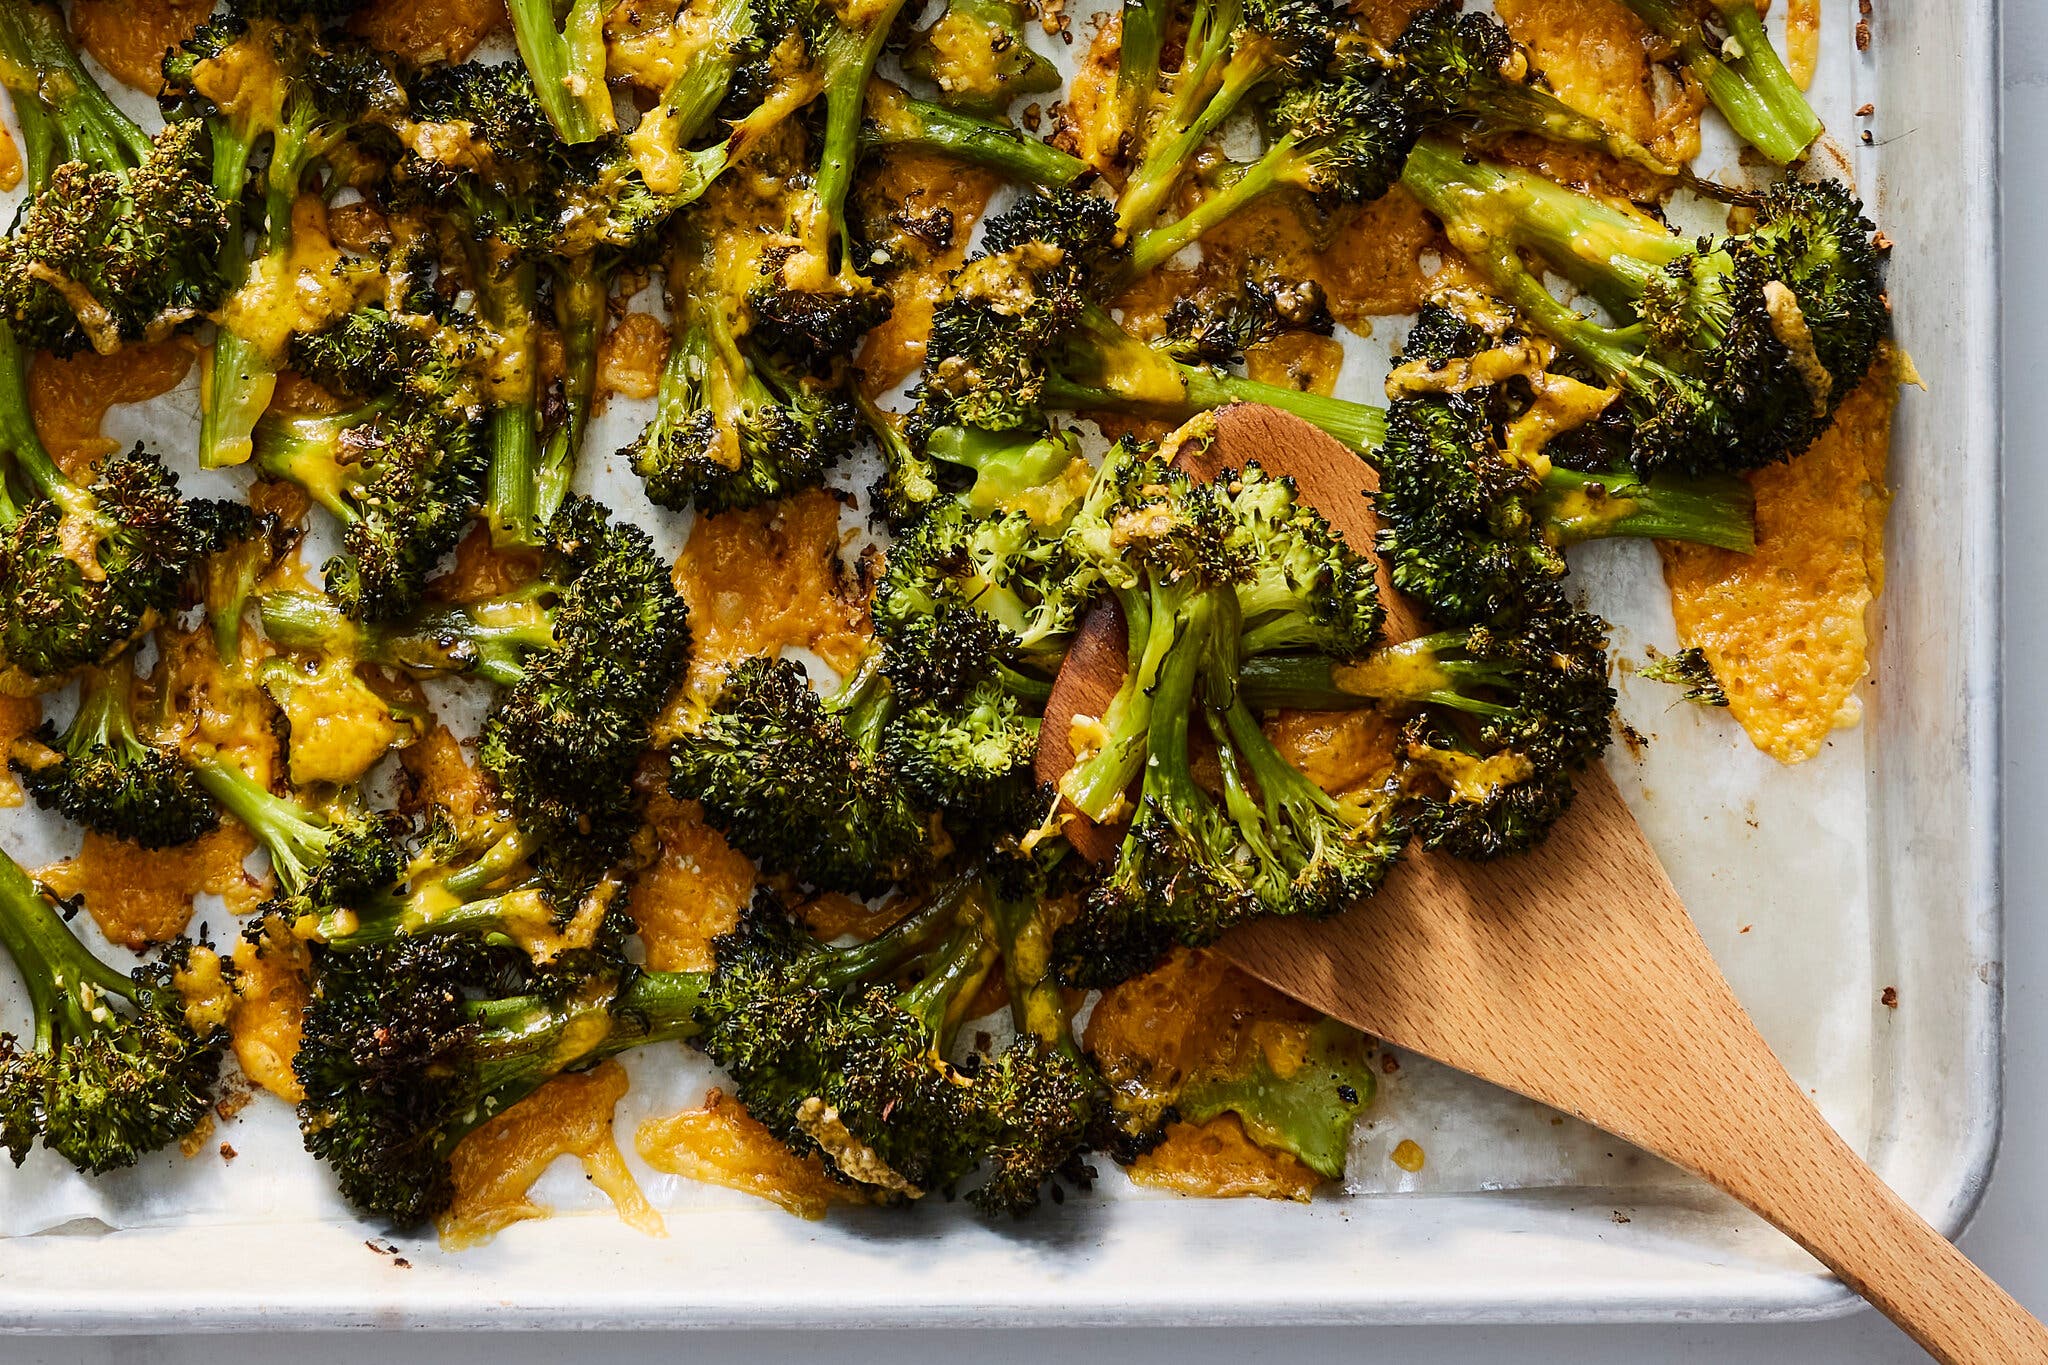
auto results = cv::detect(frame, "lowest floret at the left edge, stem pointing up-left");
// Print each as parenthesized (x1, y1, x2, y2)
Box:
(0, 853, 227, 1175)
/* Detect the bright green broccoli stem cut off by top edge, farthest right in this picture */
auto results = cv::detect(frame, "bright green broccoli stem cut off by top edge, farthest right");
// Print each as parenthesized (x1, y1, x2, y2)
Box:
(1624, 0, 1823, 166)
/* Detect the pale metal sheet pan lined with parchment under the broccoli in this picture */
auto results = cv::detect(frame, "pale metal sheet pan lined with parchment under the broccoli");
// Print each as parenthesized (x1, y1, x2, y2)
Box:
(0, 0, 2001, 1332)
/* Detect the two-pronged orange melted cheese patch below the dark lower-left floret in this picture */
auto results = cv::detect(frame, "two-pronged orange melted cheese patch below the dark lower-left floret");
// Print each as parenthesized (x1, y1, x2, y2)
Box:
(434, 1062, 664, 1250)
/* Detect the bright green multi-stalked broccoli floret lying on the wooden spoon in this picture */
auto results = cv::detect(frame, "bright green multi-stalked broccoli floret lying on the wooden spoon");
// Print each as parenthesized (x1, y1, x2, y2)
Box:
(1057, 452, 1405, 984)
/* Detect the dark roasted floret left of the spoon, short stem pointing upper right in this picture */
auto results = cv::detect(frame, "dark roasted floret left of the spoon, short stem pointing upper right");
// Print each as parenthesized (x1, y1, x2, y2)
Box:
(668, 657, 930, 894)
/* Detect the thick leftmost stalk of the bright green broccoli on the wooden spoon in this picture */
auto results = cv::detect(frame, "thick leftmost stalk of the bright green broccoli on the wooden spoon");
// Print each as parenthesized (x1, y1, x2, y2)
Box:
(1059, 579, 1210, 825)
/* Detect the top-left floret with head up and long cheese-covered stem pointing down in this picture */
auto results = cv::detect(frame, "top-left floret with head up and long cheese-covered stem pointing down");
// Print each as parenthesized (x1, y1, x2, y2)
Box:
(162, 6, 406, 469)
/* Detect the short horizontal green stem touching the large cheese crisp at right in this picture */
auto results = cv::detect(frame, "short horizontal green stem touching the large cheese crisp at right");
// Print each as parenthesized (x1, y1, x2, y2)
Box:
(1534, 467, 1757, 555)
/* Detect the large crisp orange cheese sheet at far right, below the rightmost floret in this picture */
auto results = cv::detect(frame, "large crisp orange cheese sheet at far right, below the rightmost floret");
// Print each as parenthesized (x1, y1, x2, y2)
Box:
(1659, 364, 1898, 763)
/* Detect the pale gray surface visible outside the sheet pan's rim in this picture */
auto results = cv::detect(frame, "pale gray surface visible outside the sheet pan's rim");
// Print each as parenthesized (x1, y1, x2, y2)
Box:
(0, 0, 2048, 1365)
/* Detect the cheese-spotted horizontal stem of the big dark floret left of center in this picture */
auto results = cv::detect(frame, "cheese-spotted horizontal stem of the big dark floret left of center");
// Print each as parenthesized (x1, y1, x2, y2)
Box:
(256, 583, 555, 688)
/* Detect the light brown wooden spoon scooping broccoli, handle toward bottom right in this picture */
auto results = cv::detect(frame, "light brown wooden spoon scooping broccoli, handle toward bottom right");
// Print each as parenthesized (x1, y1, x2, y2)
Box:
(1038, 407, 2048, 1365)
